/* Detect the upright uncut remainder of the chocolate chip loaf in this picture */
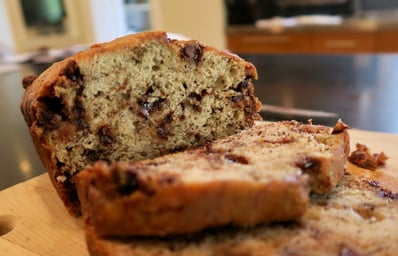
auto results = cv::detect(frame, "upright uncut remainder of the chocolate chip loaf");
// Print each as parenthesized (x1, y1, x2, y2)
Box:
(21, 31, 261, 215)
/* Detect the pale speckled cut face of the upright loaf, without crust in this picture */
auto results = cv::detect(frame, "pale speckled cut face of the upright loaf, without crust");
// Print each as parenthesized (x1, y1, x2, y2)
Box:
(48, 35, 256, 176)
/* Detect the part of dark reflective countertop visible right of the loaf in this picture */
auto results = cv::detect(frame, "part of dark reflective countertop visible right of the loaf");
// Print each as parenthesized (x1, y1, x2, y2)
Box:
(246, 54, 398, 134)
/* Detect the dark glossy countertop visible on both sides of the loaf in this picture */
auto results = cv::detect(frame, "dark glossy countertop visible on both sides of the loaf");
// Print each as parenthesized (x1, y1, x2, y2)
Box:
(0, 55, 398, 190)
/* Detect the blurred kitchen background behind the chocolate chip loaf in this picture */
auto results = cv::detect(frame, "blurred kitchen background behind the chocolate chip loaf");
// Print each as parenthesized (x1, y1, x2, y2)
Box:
(0, 0, 398, 189)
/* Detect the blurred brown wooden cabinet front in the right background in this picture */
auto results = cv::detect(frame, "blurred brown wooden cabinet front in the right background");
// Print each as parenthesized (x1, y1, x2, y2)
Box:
(227, 22, 398, 54)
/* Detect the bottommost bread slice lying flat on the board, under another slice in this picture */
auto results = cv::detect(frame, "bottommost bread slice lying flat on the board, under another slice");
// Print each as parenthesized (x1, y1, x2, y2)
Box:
(86, 170, 398, 256)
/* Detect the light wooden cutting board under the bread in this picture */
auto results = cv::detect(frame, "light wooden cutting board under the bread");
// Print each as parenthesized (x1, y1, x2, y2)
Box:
(0, 129, 398, 256)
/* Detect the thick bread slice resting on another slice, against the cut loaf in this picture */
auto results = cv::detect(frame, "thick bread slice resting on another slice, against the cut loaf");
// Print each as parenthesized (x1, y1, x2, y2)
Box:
(76, 121, 349, 237)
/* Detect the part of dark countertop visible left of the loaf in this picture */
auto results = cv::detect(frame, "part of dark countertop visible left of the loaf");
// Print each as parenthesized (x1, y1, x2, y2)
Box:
(0, 65, 45, 189)
